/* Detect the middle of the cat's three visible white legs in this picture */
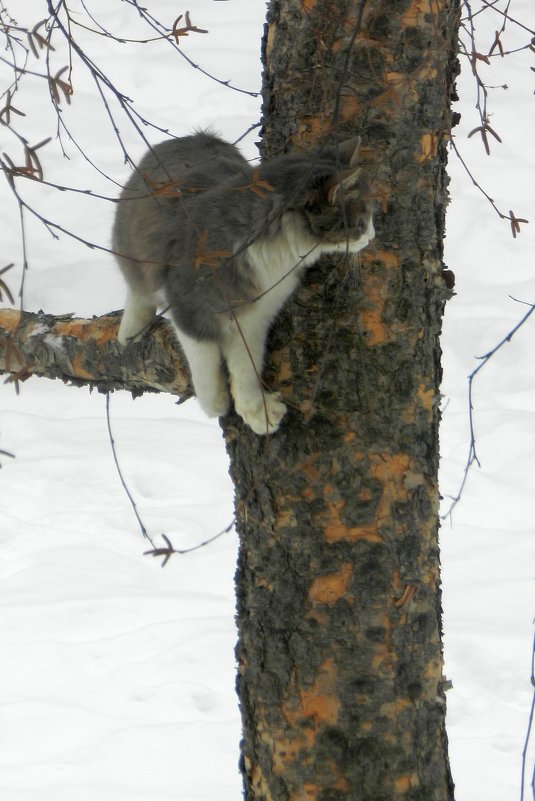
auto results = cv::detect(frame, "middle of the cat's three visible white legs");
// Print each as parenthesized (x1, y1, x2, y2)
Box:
(173, 323, 230, 417)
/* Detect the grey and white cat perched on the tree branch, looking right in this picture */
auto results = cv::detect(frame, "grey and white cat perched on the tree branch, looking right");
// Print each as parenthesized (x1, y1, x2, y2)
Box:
(112, 132, 375, 435)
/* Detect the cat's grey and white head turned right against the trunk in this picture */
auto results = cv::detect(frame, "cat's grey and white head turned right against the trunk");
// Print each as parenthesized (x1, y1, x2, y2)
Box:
(262, 137, 373, 249)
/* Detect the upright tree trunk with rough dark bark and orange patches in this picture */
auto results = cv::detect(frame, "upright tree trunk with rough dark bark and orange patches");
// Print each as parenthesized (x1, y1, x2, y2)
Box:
(225, 0, 459, 801)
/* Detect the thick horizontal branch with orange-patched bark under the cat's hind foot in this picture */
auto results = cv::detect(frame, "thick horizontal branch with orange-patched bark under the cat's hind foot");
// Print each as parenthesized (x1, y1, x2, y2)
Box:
(0, 309, 193, 400)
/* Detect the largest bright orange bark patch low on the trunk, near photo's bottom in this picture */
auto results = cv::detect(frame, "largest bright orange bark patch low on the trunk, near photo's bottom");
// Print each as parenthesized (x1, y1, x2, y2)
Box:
(282, 659, 340, 731)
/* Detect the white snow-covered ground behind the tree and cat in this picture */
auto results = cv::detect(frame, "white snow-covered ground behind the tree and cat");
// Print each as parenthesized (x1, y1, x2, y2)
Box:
(0, 0, 535, 801)
